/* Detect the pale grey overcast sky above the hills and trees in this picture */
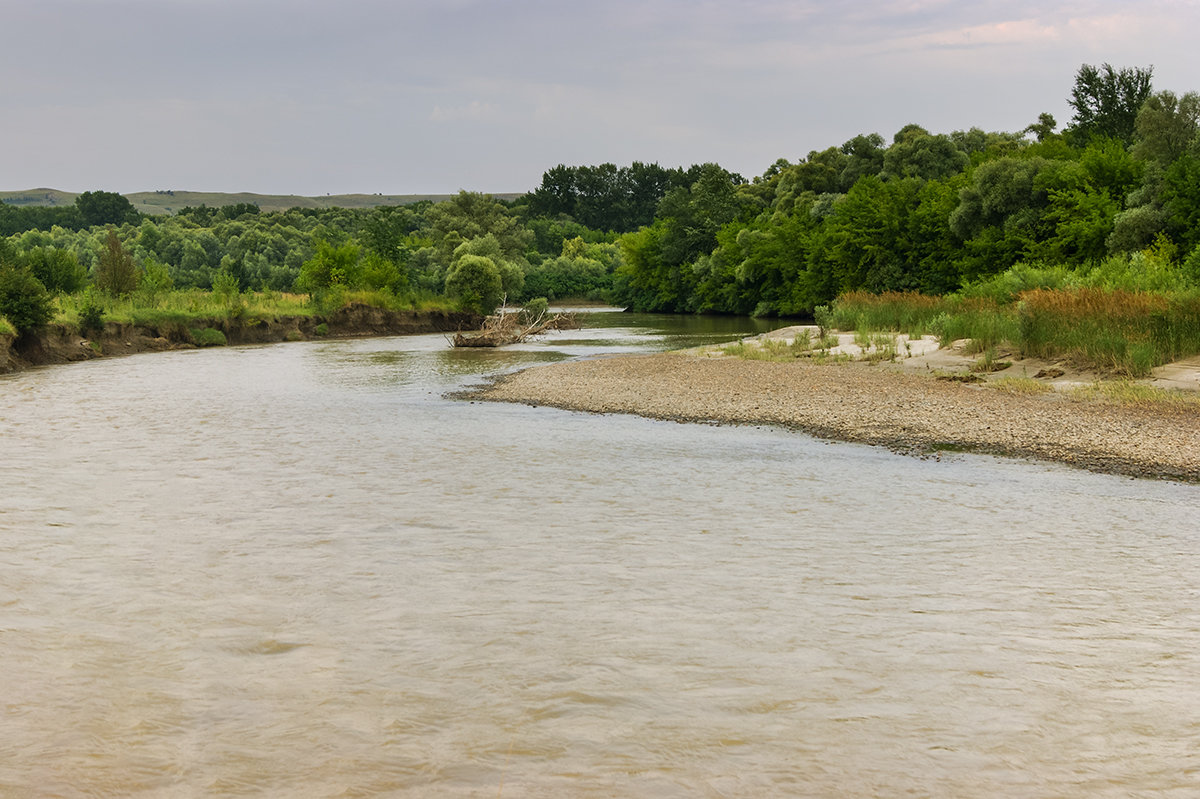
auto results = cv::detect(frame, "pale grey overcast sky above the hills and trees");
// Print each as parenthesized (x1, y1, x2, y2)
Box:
(0, 0, 1200, 194)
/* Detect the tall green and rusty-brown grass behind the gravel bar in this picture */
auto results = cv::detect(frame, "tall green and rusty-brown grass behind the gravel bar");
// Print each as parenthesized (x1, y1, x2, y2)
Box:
(832, 287, 1200, 377)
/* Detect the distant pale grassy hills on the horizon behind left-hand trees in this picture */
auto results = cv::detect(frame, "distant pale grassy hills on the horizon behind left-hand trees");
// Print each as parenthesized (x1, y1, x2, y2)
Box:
(0, 188, 521, 215)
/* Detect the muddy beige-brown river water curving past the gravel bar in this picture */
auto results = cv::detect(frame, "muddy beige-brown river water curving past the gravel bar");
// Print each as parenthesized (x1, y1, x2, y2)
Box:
(0, 314, 1200, 798)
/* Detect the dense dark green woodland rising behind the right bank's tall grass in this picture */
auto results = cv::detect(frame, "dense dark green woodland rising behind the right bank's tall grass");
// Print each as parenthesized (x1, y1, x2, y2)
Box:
(617, 65, 1200, 314)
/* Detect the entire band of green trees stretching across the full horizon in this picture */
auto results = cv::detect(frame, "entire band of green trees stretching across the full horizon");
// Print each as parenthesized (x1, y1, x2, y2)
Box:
(0, 65, 1200, 328)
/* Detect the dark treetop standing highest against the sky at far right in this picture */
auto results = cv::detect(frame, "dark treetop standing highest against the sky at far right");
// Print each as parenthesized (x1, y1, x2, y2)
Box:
(1067, 64, 1154, 146)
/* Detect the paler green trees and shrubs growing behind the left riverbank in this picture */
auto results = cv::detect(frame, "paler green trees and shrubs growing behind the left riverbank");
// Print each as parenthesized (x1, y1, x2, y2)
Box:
(0, 192, 620, 323)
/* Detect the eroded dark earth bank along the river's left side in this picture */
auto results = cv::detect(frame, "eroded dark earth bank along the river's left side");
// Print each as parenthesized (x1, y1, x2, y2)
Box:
(0, 304, 481, 374)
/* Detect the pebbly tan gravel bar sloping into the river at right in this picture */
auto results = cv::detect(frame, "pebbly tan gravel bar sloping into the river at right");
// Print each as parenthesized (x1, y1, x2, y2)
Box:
(460, 352, 1200, 483)
